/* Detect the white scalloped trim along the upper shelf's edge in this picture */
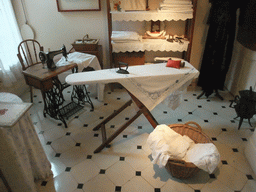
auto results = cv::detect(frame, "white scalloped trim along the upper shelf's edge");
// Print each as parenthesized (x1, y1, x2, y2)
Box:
(111, 10, 193, 21)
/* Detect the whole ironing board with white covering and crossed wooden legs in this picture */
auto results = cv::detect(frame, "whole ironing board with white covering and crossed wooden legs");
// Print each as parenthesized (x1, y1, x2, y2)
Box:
(66, 61, 199, 153)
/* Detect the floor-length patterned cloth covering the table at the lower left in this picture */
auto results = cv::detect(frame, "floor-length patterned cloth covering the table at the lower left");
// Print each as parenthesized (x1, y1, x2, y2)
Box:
(0, 102, 52, 192)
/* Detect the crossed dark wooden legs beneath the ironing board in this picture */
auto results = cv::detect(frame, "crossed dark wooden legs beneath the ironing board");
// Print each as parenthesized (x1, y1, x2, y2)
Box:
(93, 88, 158, 153)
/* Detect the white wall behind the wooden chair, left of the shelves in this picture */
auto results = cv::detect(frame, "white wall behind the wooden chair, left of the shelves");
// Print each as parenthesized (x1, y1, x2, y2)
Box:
(12, 0, 108, 65)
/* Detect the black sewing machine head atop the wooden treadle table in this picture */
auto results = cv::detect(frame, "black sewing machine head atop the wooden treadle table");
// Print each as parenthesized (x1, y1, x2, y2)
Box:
(39, 45, 68, 70)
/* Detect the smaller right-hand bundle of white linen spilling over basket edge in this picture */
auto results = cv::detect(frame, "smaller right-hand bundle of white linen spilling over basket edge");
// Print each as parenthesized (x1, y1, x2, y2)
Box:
(184, 143, 220, 174)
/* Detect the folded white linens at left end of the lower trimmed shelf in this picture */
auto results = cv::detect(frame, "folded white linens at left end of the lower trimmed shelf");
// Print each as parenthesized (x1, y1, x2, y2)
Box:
(111, 31, 142, 43)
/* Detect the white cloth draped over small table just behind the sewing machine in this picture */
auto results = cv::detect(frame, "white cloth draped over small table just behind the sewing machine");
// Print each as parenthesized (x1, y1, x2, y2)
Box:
(56, 52, 104, 101)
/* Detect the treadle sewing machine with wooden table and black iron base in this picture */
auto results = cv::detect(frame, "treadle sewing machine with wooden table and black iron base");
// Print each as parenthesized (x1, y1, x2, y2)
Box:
(23, 45, 93, 128)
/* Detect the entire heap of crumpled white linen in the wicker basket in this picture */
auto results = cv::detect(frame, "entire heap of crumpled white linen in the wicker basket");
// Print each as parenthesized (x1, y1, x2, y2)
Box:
(147, 124, 220, 173)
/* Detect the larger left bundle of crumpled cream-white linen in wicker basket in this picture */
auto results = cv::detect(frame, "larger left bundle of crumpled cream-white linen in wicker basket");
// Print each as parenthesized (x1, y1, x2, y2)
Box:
(147, 124, 194, 167)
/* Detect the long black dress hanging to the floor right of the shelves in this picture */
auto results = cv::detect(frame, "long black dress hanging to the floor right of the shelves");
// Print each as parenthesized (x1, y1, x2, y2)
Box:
(198, 0, 239, 97)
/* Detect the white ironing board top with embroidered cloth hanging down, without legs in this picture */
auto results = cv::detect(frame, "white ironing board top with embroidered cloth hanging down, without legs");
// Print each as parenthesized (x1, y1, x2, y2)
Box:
(66, 62, 199, 110)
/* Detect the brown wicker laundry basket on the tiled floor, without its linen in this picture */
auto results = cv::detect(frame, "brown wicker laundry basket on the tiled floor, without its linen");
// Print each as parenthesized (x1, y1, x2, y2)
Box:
(165, 121, 212, 179)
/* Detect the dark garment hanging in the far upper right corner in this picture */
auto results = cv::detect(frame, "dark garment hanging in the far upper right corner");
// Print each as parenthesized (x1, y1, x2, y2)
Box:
(237, 0, 256, 51)
